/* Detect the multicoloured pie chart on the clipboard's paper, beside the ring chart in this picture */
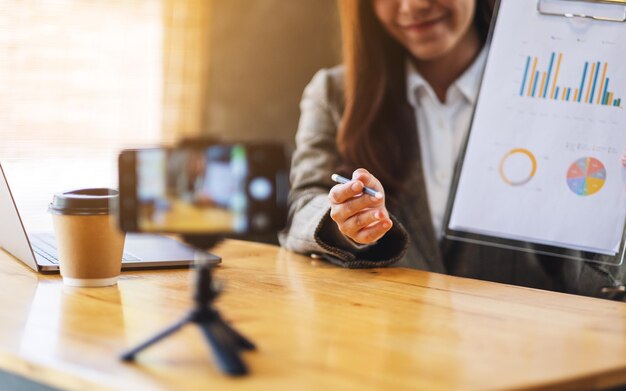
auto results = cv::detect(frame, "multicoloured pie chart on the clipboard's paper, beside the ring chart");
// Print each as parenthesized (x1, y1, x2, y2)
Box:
(567, 157, 606, 196)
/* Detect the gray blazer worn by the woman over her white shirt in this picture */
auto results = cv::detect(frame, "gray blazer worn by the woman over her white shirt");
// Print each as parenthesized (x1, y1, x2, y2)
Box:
(279, 67, 625, 298)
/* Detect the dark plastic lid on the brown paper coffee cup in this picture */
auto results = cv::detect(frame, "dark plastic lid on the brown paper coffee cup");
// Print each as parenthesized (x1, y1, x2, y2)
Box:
(48, 188, 119, 215)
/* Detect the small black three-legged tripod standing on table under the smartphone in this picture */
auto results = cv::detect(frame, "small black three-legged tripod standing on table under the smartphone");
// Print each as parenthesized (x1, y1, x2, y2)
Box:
(121, 236, 256, 376)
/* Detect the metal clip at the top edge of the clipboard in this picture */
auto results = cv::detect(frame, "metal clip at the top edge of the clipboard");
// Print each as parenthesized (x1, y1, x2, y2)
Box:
(537, 0, 626, 22)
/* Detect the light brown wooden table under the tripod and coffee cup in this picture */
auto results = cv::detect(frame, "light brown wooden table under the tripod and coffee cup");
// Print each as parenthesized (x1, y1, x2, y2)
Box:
(0, 240, 626, 391)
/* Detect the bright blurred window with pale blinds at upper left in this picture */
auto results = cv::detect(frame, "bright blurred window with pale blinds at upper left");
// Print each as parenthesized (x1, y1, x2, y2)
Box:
(0, 0, 163, 161)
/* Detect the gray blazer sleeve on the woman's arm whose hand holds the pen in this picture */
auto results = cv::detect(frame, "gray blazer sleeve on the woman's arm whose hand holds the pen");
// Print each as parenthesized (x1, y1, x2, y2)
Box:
(279, 69, 408, 267)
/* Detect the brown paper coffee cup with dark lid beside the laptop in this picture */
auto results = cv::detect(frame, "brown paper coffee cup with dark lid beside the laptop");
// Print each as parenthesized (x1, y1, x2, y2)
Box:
(48, 188, 124, 287)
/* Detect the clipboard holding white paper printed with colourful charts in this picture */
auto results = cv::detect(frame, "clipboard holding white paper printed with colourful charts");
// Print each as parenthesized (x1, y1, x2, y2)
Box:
(443, 0, 626, 265)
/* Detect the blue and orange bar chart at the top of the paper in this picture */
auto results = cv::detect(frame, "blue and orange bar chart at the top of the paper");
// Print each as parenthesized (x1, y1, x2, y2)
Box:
(519, 52, 622, 108)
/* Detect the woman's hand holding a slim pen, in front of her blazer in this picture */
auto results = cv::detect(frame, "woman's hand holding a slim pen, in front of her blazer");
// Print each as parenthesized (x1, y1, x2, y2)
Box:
(328, 168, 393, 244)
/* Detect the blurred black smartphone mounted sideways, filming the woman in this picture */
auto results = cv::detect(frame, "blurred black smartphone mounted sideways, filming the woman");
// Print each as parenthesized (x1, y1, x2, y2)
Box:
(119, 142, 288, 235)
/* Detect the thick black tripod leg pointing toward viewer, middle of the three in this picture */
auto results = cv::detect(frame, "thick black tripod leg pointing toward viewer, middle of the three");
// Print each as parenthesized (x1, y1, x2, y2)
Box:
(198, 321, 248, 376)
